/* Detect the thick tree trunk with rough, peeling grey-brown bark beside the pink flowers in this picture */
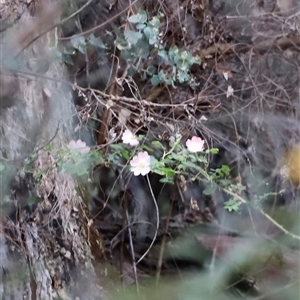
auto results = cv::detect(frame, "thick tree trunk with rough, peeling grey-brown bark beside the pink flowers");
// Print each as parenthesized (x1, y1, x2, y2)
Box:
(0, 1, 107, 299)
